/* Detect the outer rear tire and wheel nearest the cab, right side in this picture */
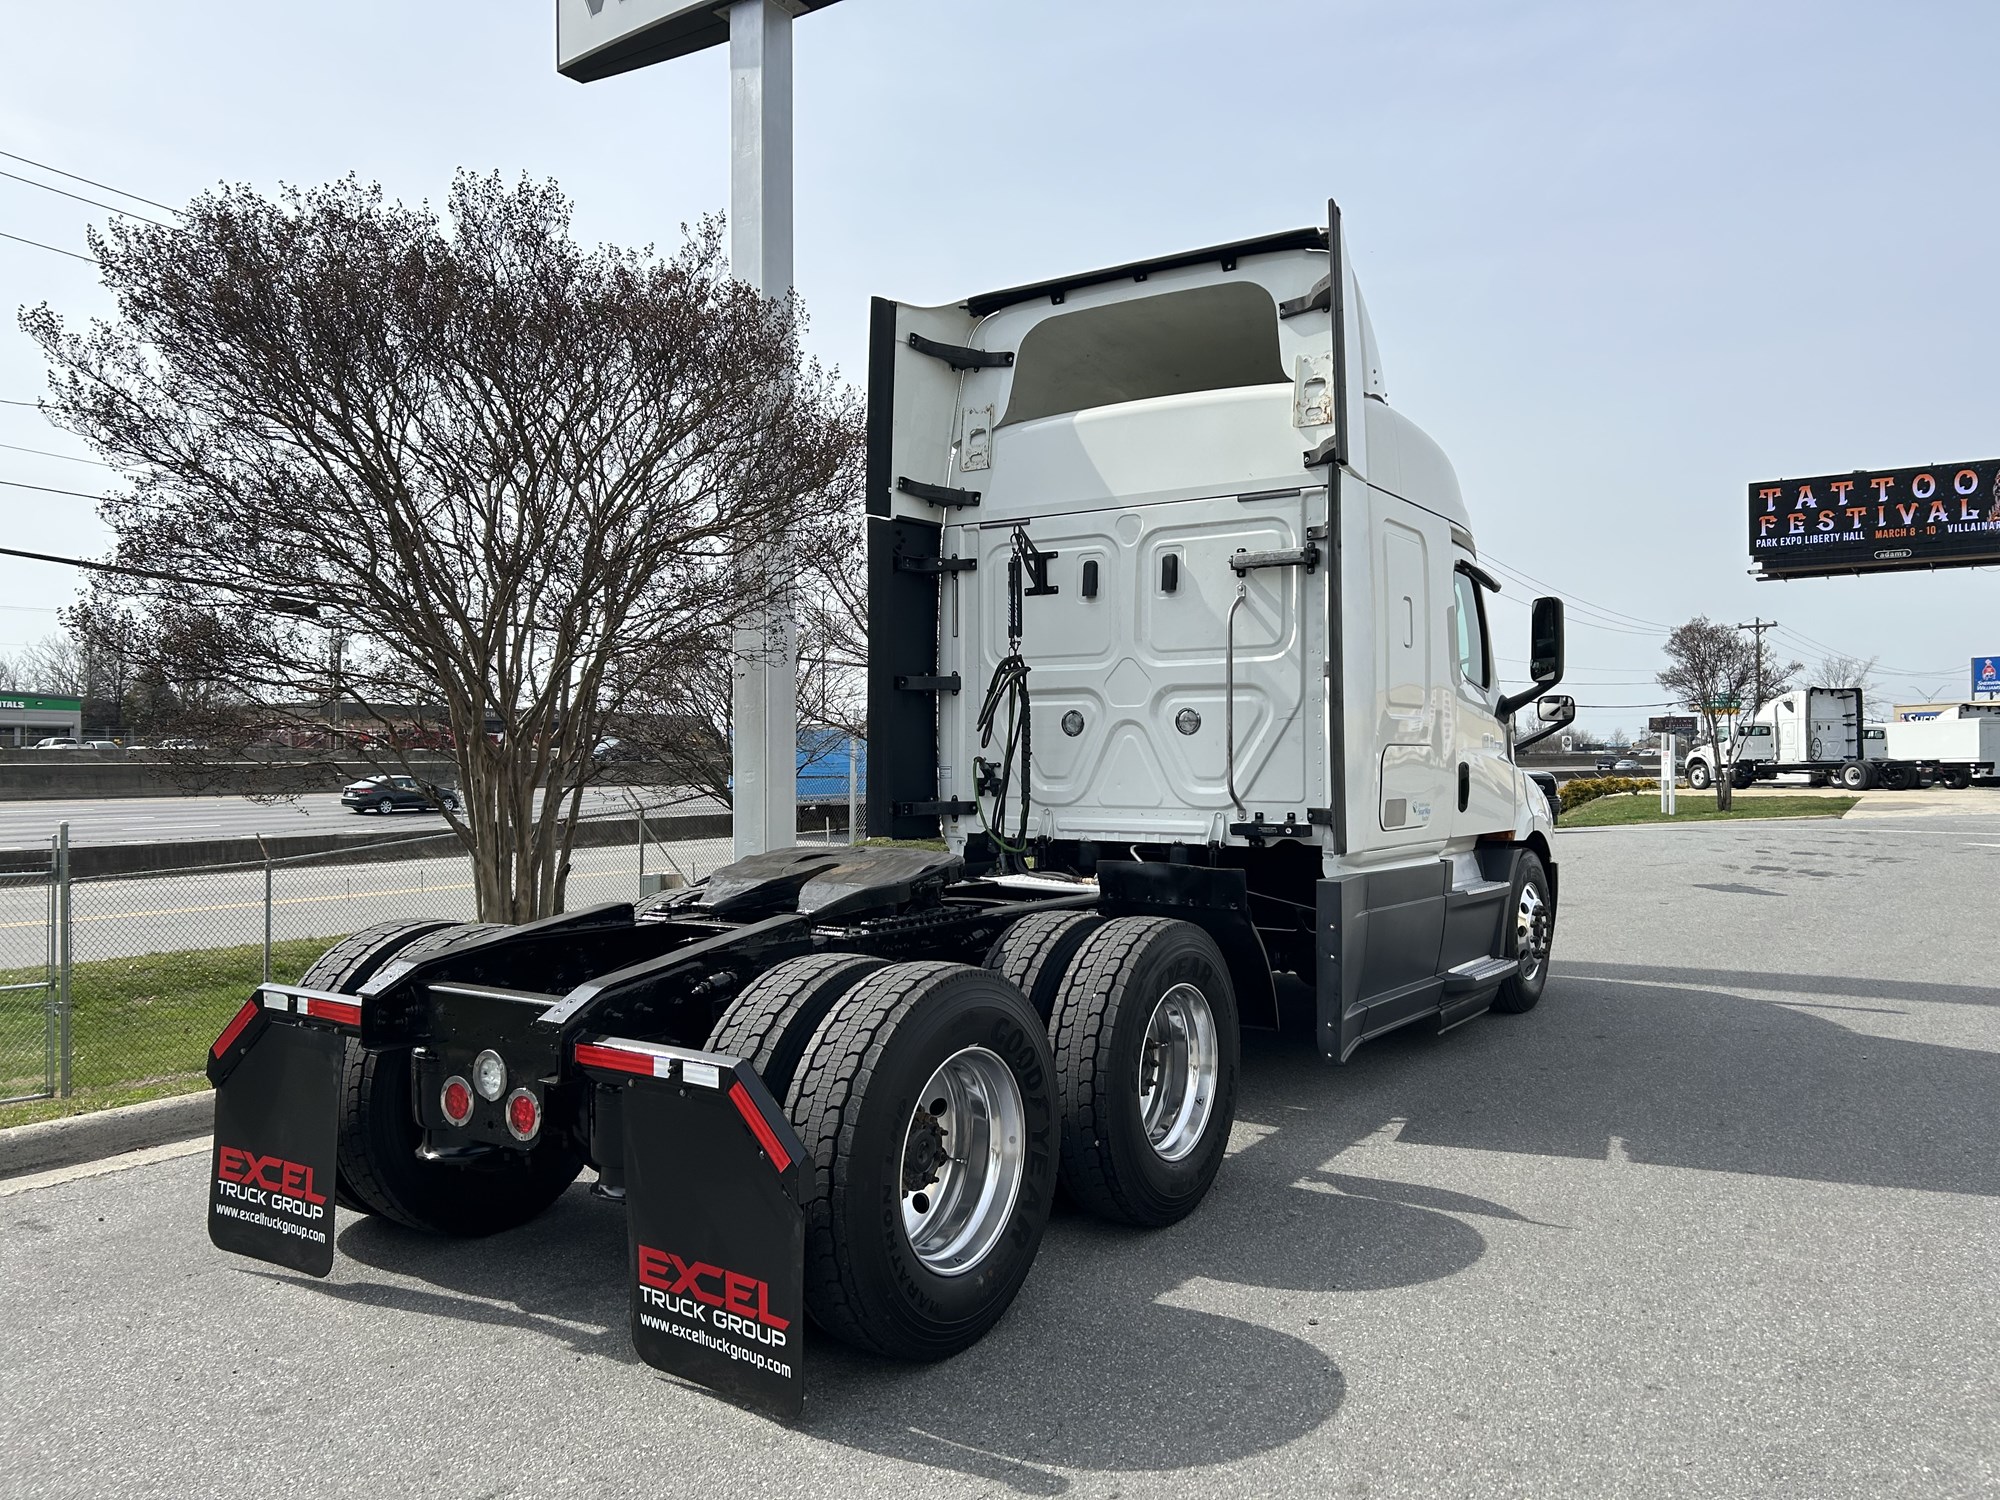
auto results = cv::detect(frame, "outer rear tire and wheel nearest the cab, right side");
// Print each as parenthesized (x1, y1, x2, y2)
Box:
(1048, 916, 1240, 1226)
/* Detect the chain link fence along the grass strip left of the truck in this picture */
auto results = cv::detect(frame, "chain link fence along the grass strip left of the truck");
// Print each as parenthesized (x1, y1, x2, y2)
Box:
(0, 798, 860, 1124)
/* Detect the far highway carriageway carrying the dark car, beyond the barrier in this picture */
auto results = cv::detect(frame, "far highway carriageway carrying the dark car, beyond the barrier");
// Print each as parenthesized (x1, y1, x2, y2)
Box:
(0, 786, 714, 850)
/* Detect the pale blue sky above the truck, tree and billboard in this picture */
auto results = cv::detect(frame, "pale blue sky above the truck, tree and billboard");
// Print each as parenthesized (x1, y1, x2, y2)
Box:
(0, 0, 2000, 728)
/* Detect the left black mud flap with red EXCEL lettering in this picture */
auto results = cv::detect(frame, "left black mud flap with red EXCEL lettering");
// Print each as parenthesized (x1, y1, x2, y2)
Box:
(208, 1024, 346, 1276)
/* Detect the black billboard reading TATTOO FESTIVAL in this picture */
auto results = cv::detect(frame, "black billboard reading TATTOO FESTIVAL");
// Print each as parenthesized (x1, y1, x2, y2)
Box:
(1750, 458, 2000, 578)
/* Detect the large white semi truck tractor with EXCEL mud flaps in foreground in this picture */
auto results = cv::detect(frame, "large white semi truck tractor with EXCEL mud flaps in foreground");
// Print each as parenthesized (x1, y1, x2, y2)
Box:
(208, 206, 1574, 1414)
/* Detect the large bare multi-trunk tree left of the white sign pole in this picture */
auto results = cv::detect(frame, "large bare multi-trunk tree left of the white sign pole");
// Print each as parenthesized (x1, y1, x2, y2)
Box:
(22, 174, 862, 922)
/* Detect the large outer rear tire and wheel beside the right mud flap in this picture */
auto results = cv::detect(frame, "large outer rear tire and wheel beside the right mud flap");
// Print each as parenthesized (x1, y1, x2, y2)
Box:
(788, 962, 1060, 1360)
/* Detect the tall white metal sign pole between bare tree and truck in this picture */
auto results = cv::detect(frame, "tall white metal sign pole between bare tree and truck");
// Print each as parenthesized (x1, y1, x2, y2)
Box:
(730, 0, 798, 858)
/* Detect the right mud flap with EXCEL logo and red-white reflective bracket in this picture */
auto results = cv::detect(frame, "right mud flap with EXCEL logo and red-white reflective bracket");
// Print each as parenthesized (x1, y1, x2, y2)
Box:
(576, 1038, 812, 1418)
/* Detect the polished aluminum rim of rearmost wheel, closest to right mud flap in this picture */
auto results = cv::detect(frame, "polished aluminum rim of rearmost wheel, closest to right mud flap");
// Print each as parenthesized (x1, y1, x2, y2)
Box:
(900, 1046, 1028, 1276)
